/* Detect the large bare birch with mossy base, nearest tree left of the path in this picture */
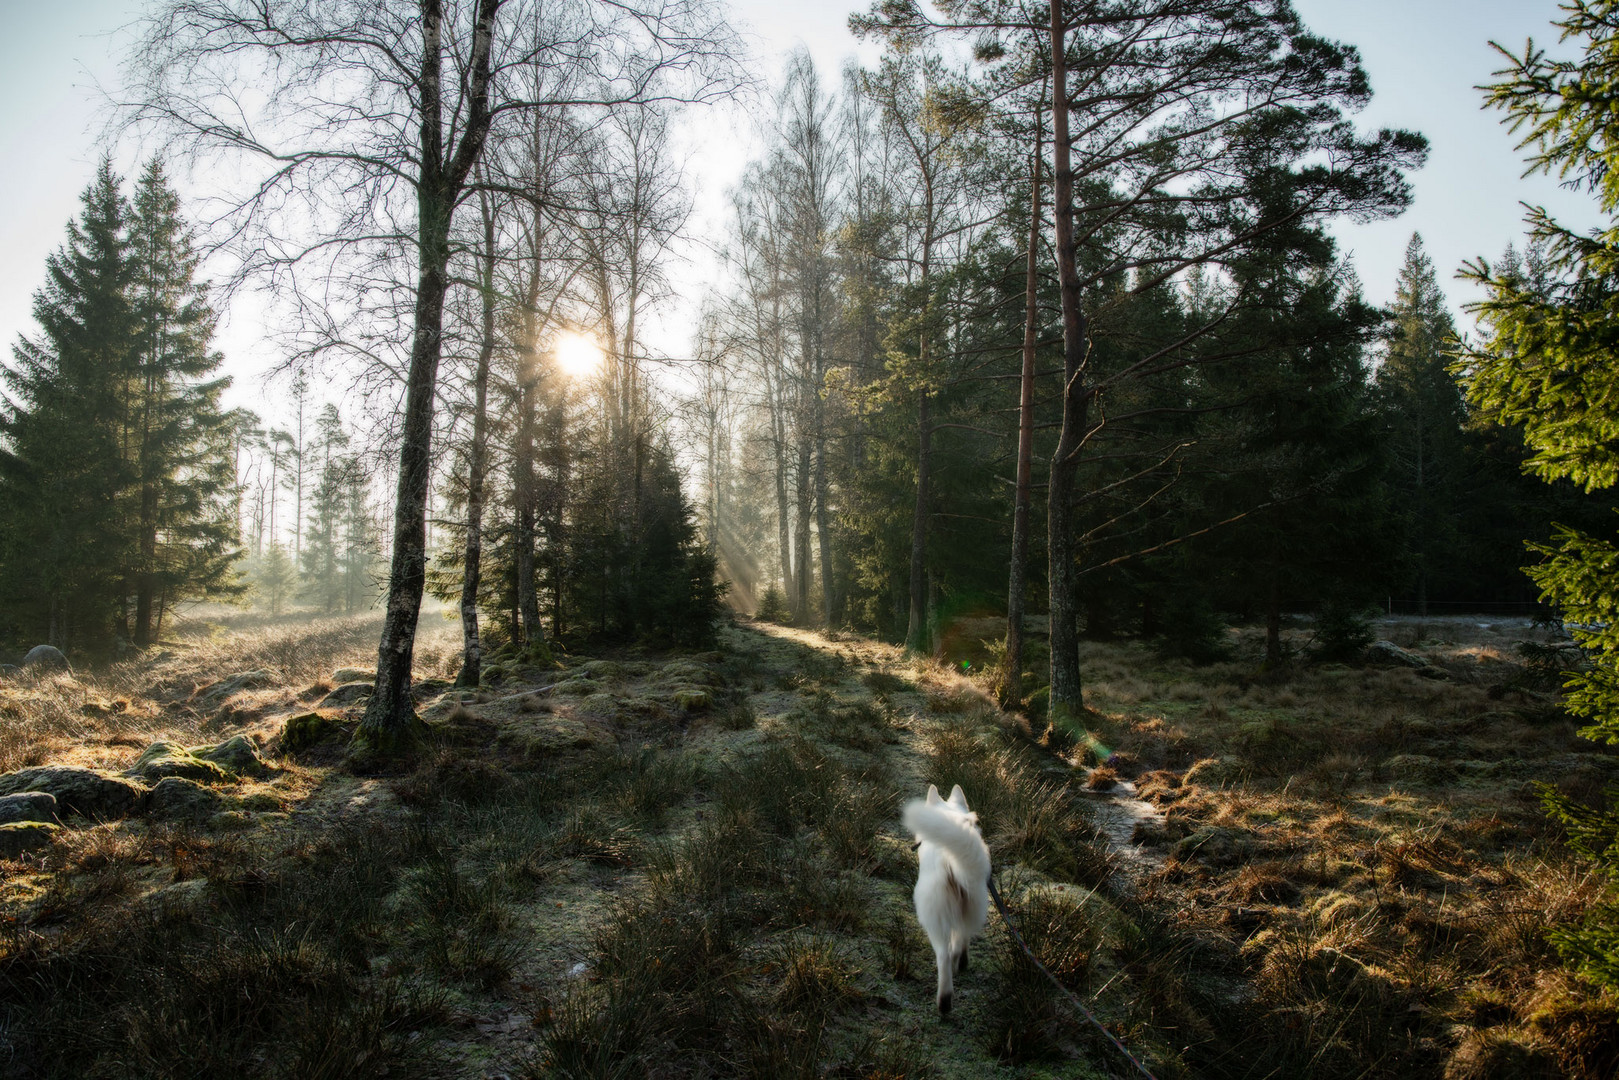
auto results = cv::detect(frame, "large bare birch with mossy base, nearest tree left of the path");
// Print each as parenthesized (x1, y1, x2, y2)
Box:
(128, 0, 737, 750)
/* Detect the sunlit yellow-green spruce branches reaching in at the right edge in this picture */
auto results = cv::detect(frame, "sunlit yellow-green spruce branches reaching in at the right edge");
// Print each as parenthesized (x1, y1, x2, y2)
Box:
(1457, 0, 1619, 988)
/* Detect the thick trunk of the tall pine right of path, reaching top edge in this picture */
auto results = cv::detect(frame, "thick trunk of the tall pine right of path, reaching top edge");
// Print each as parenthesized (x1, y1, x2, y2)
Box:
(1046, 2, 1090, 721)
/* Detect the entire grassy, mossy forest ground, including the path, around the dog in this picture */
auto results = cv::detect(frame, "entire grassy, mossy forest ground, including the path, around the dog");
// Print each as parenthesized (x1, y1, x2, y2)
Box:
(0, 619, 1619, 1080)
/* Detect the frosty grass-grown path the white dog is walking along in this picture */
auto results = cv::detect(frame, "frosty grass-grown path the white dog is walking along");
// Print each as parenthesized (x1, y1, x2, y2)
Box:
(440, 623, 1139, 1080)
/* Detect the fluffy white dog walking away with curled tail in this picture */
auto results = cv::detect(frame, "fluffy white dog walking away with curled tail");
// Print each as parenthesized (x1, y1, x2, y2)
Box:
(903, 784, 989, 1012)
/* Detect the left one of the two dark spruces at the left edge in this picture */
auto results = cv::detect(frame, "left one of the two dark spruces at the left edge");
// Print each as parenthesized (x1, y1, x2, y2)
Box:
(0, 160, 138, 649)
